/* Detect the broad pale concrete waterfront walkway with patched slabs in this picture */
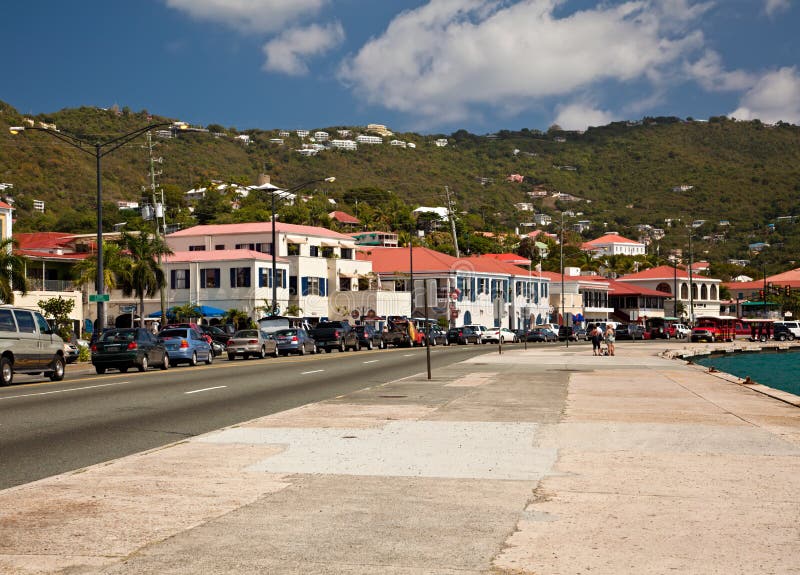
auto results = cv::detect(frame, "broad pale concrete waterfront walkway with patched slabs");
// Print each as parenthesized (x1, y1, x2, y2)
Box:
(0, 343, 800, 575)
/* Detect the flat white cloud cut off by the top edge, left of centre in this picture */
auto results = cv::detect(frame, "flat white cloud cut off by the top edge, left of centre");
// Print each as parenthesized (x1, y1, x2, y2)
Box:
(166, 0, 328, 32)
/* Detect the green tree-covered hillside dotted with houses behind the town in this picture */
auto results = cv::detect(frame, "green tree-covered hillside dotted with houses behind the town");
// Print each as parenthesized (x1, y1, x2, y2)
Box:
(0, 102, 800, 274)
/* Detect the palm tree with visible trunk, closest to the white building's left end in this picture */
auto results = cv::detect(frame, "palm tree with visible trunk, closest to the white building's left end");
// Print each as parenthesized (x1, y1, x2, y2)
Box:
(120, 232, 172, 327)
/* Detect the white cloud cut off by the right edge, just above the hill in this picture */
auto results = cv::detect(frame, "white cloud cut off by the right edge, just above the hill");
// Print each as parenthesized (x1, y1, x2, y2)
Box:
(730, 67, 800, 125)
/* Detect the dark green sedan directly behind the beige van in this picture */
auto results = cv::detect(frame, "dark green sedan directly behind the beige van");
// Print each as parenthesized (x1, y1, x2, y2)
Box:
(92, 327, 172, 373)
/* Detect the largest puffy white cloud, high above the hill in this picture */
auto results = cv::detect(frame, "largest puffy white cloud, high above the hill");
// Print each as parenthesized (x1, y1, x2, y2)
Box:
(340, 0, 710, 122)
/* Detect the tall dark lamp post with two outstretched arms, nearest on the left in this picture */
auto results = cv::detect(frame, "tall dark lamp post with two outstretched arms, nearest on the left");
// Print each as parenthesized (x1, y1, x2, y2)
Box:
(9, 122, 188, 333)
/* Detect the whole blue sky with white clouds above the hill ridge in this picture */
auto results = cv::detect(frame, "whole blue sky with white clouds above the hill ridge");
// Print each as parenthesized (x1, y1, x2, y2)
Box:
(0, 0, 800, 134)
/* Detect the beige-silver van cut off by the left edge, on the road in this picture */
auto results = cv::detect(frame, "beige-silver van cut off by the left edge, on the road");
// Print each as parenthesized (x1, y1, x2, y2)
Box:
(0, 306, 65, 385)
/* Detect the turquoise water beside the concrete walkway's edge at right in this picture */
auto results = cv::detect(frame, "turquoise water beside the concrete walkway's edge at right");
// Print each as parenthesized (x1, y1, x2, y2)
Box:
(695, 351, 800, 395)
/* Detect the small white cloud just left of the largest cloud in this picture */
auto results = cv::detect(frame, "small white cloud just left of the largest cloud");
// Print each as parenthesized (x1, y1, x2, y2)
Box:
(263, 22, 344, 76)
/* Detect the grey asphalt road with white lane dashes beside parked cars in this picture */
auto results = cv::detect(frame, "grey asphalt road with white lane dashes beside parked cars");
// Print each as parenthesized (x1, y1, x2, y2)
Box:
(0, 344, 532, 489)
